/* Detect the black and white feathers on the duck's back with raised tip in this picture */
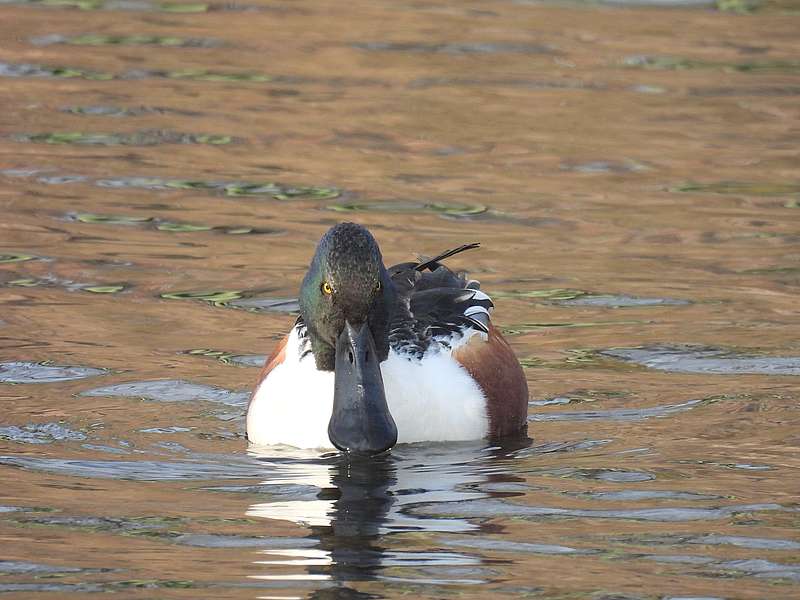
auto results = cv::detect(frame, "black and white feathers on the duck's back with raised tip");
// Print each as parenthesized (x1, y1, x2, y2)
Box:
(389, 244, 493, 356)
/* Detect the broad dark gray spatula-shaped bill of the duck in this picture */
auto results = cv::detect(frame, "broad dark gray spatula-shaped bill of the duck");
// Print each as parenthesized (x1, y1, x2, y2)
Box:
(328, 322, 397, 454)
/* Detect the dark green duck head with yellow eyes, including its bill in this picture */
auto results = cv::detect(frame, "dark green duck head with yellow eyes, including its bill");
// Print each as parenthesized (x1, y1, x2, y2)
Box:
(300, 223, 397, 454)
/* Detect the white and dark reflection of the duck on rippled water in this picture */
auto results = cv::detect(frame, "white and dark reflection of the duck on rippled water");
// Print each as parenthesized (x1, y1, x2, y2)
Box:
(247, 438, 530, 597)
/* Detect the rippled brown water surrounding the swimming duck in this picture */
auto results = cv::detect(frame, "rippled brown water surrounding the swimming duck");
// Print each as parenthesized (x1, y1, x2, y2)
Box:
(0, 0, 800, 600)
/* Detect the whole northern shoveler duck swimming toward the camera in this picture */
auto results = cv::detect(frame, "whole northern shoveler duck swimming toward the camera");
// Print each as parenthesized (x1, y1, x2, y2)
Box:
(247, 223, 528, 454)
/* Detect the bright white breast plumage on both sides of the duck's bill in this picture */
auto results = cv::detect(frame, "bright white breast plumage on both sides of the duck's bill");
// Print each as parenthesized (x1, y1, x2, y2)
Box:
(247, 330, 489, 448)
